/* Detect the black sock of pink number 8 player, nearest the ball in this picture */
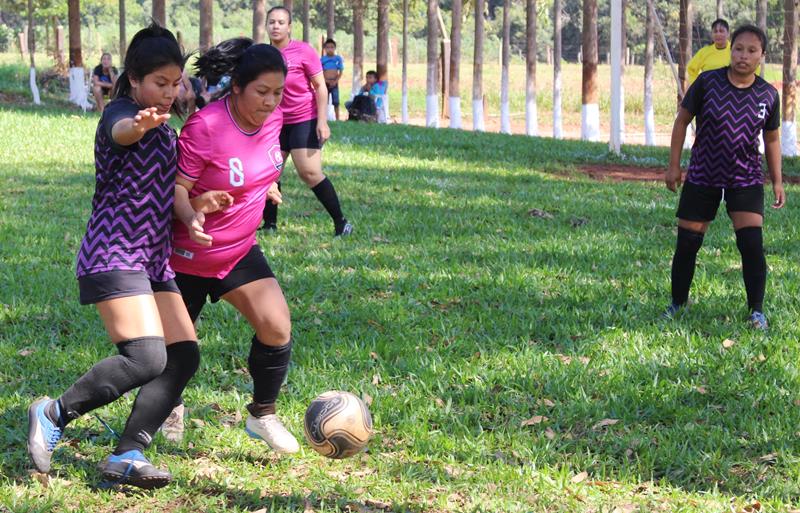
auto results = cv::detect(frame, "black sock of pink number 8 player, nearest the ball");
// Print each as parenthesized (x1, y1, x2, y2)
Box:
(247, 336, 292, 417)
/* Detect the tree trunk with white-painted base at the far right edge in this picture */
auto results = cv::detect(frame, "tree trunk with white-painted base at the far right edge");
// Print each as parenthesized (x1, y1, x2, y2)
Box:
(781, 0, 798, 156)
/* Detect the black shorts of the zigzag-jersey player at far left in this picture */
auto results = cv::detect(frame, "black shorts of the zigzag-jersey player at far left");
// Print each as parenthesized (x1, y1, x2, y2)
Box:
(78, 271, 180, 305)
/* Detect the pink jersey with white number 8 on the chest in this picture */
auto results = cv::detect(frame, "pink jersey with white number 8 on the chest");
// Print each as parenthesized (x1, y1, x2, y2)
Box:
(170, 97, 283, 278)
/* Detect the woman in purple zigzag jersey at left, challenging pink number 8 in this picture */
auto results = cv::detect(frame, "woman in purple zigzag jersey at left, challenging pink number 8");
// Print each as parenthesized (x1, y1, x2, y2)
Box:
(28, 24, 209, 488)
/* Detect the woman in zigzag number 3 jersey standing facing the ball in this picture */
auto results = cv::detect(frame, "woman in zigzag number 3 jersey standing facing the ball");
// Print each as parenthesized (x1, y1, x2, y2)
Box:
(664, 25, 786, 330)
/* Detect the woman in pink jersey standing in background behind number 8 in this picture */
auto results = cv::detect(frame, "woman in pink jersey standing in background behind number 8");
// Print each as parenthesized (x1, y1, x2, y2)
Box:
(264, 6, 353, 237)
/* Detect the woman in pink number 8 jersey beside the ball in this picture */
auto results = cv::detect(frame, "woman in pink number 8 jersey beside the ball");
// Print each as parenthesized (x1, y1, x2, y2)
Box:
(170, 38, 299, 454)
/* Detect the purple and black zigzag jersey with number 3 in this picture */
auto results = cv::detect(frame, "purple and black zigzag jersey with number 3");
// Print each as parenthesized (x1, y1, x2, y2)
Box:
(681, 67, 780, 188)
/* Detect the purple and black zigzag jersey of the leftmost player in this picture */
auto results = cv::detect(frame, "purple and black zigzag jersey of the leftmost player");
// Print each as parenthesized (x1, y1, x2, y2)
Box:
(77, 97, 177, 282)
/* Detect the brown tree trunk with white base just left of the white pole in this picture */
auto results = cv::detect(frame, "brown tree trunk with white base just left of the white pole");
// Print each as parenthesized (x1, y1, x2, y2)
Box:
(581, 0, 600, 141)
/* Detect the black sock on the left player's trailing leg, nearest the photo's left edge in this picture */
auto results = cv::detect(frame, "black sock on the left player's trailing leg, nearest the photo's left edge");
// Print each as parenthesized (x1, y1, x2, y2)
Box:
(58, 337, 167, 428)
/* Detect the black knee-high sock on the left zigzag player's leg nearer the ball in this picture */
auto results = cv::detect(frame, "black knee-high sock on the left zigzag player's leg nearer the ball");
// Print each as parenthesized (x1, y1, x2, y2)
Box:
(114, 340, 200, 454)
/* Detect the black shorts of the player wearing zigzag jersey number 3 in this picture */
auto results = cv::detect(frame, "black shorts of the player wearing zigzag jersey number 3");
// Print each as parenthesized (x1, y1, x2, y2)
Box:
(675, 182, 764, 222)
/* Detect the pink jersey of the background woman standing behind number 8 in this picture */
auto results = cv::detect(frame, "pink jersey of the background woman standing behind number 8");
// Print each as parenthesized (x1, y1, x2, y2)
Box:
(281, 40, 322, 124)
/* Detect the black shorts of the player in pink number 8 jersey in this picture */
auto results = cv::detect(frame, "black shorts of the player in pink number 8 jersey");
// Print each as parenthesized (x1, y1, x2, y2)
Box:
(175, 244, 275, 322)
